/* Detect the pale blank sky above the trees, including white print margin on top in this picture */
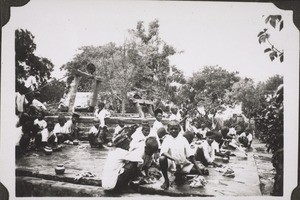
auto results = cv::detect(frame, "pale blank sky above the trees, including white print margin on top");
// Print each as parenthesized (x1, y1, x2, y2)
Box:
(7, 0, 299, 82)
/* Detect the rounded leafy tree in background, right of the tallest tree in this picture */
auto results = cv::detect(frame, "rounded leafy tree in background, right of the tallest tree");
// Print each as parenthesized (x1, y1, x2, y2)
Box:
(179, 66, 240, 114)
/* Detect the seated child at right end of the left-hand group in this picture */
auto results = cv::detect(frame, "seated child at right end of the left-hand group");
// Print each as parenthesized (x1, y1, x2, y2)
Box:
(65, 113, 80, 144)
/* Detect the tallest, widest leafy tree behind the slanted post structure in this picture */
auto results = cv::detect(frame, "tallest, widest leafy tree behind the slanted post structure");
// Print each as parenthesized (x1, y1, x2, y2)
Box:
(62, 20, 184, 112)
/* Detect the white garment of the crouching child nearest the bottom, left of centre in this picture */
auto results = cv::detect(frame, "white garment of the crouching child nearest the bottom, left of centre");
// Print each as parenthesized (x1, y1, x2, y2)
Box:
(102, 148, 142, 190)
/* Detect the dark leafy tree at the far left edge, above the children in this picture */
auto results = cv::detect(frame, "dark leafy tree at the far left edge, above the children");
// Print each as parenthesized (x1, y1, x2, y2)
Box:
(15, 29, 54, 90)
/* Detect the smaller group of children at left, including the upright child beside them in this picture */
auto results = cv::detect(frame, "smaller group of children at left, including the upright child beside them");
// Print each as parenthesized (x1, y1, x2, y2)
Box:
(15, 100, 110, 157)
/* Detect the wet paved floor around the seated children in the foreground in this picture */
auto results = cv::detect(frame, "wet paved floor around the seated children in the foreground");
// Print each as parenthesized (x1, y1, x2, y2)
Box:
(16, 140, 274, 197)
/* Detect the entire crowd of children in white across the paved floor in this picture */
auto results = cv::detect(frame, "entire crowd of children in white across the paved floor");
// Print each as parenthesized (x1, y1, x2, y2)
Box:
(16, 97, 253, 191)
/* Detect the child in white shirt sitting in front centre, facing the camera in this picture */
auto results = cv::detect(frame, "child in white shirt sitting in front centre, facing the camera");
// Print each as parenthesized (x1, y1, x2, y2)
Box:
(159, 120, 202, 189)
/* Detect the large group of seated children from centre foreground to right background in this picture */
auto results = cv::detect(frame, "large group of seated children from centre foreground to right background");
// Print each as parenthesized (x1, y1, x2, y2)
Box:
(102, 105, 252, 191)
